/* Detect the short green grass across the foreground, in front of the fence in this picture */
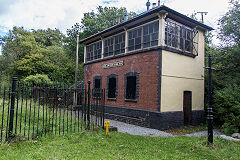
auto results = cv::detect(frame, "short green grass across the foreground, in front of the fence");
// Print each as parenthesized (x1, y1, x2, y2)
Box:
(0, 129, 240, 159)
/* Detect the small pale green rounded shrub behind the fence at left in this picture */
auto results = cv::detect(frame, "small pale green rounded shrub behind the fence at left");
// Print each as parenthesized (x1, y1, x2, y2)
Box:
(23, 74, 53, 86)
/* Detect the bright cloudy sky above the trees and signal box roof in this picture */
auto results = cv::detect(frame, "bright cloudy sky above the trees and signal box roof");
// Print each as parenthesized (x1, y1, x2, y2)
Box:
(0, 0, 229, 52)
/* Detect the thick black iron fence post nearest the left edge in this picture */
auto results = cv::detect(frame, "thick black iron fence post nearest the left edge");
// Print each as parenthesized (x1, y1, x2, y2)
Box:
(8, 77, 18, 138)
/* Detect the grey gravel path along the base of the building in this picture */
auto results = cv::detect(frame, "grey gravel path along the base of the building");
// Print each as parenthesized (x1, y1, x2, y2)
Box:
(105, 119, 240, 141)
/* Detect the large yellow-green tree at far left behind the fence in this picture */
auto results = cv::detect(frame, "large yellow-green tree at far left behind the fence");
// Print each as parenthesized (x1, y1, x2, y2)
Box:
(0, 27, 74, 84)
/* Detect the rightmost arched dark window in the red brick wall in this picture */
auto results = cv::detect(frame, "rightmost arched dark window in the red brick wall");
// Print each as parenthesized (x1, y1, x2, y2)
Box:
(125, 72, 139, 100)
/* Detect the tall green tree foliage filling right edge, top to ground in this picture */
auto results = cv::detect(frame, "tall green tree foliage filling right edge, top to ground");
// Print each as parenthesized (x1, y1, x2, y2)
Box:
(211, 0, 240, 134)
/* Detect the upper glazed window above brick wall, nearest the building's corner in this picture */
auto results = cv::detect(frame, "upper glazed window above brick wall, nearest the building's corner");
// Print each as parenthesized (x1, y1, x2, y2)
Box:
(128, 21, 159, 51)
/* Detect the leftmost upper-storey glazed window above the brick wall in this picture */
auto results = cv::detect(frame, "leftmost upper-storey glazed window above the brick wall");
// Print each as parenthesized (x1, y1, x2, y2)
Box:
(86, 41, 102, 61)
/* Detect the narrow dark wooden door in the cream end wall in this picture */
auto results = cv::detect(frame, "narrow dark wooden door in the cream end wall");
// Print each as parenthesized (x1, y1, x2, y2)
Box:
(183, 91, 192, 125)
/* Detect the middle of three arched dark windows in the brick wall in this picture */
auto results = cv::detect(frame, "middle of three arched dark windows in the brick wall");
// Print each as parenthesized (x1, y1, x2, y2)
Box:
(107, 74, 117, 98)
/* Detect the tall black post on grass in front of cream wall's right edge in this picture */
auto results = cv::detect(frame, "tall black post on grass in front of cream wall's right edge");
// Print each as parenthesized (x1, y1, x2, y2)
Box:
(207, 54, 213, 143)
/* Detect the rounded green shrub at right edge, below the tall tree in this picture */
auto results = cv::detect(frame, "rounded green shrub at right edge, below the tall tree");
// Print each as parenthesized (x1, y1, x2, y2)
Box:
(214, 83, 240, 134)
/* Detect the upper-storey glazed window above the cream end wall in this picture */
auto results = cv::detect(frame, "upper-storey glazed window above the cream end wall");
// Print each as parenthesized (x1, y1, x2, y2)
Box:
(165, 19, 198, 54)
